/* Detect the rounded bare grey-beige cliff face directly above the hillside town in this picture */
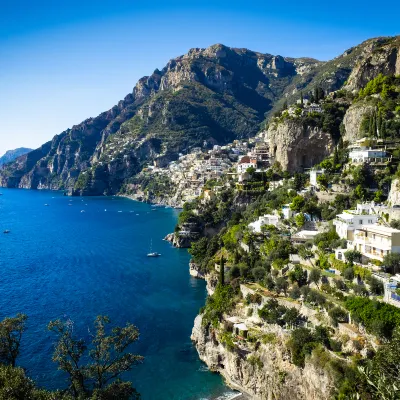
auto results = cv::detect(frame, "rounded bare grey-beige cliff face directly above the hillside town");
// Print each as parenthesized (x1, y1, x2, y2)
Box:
(265, 119, 334, 172)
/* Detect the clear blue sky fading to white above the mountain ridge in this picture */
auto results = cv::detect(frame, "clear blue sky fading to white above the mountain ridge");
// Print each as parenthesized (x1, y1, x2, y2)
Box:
(0, 0, 400, 155)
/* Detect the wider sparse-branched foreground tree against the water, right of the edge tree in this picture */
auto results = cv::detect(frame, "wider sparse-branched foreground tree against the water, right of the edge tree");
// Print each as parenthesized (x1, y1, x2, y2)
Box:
(48, 316, 143, 400)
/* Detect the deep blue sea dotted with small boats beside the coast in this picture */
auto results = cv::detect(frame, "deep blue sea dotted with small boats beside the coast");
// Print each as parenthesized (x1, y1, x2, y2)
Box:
(0, 189, 234, 400)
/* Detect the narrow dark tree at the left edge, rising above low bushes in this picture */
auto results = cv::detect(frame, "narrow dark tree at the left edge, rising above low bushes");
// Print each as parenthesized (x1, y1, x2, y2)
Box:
(0, 314, 28, 367)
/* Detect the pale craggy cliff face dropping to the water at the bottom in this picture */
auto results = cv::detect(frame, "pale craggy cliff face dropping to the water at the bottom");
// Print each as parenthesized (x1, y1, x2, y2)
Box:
(191, 315, 333, 400)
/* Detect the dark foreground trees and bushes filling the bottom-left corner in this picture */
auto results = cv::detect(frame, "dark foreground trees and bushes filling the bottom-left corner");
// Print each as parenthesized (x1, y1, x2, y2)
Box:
(0, 314, 143, 400)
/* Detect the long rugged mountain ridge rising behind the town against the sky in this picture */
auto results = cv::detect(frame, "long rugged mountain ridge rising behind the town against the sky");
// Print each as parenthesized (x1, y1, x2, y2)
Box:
(0, 37, 400, 195)
